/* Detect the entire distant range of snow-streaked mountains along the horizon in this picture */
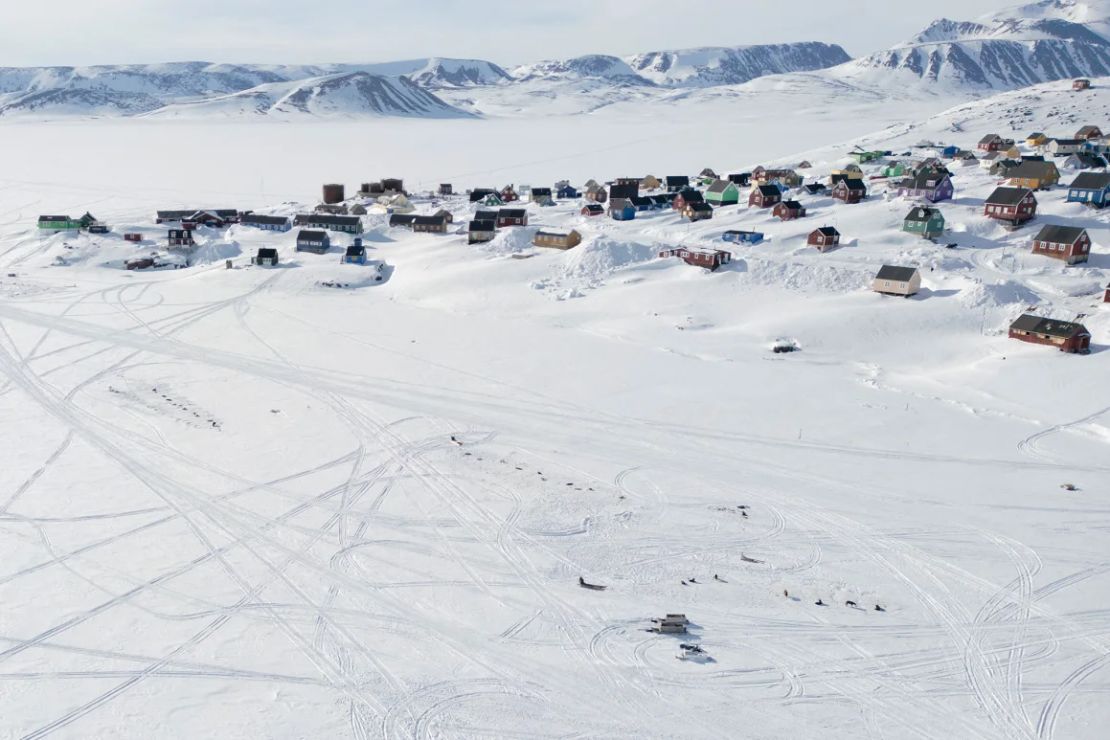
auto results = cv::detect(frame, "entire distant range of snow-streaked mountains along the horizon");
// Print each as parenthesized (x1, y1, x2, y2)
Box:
(0, 0, 1110, 119)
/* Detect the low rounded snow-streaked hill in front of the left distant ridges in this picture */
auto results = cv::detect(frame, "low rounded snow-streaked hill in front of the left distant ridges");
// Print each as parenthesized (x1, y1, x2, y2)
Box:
(140, 72, 470, 118)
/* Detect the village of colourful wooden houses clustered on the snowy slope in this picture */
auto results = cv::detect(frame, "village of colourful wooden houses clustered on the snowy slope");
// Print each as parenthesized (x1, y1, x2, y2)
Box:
(37, 80, 1110, 354)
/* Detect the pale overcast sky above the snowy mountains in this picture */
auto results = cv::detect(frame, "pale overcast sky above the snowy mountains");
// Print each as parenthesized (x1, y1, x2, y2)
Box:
(0, 0, 1015, 67)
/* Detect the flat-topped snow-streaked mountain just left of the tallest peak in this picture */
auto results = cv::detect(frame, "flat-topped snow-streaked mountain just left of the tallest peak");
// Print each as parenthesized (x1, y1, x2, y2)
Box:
(627, 42, 851, 88)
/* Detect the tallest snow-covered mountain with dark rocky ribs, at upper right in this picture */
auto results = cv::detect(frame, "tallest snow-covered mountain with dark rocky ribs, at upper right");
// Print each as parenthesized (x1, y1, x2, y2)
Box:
(834, 0, 1110, 90)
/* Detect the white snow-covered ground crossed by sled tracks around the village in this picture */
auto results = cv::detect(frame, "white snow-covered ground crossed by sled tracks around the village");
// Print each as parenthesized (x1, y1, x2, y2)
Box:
(0, 80, 1110, 740)
